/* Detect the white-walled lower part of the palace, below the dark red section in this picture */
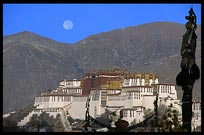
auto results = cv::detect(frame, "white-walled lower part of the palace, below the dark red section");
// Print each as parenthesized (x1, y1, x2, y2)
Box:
(35, 80, 180, 126)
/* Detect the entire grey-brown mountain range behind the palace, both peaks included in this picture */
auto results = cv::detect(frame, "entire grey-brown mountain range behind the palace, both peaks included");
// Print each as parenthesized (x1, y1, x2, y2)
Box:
(3, 22, 201, 112)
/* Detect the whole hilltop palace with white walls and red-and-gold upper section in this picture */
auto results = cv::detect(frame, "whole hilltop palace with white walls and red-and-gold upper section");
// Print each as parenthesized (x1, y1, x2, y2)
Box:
(13, 69, 201, 130)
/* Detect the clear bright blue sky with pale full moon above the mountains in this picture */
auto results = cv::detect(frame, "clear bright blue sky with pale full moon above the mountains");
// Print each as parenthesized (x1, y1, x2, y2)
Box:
(3, 3, 201, 44)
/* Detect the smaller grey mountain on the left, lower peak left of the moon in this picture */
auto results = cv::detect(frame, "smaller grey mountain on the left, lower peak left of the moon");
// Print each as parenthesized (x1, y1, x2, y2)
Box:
(3, 32, 81, 111)
